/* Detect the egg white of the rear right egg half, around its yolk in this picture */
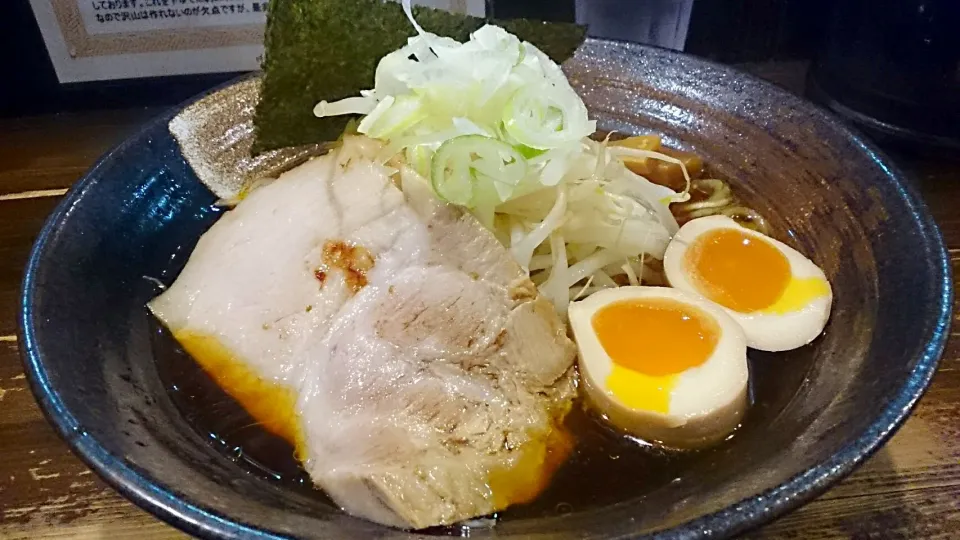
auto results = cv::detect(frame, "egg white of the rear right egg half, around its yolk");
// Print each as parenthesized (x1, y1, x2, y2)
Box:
(663, 216, 833, 351)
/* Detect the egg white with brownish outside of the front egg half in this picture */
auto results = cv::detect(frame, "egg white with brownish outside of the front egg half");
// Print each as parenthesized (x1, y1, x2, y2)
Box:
(569, 287, 749, 448)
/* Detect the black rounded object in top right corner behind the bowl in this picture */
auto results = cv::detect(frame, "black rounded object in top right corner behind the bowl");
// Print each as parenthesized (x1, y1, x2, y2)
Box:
(807, 0, 960, 151)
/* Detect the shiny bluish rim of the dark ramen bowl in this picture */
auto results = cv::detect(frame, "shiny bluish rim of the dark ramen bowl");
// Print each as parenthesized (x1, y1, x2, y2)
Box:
(18, 38, 953, 540)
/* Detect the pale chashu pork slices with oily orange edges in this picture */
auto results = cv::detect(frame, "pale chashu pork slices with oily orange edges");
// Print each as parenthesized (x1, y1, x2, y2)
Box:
(150, 138, 575, 528)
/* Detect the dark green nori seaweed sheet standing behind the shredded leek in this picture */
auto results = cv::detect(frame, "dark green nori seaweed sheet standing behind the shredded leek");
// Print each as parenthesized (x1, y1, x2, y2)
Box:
(253, 0, 586, 154)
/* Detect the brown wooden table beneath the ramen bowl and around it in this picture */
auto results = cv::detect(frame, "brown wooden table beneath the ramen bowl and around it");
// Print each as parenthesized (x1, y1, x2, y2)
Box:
(0, 66, 960, 540)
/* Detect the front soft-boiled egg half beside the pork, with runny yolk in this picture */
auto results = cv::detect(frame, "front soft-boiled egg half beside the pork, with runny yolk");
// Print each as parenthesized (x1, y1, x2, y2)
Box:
(568, 287, 748, 448)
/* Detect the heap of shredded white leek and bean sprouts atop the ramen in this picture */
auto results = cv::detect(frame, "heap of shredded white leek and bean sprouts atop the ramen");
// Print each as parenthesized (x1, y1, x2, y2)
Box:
(314, 0, 690, 314)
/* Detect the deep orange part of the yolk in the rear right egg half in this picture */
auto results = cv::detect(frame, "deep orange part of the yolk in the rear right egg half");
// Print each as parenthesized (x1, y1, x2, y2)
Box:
(686, 229, 793, 313)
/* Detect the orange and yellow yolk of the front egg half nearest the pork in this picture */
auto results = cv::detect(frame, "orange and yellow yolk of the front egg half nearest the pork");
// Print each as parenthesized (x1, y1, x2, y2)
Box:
(591, 298, 720, 413)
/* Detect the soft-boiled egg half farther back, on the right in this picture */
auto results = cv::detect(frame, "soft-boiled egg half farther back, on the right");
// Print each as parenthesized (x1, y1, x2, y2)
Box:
(663, 216, 833, 351)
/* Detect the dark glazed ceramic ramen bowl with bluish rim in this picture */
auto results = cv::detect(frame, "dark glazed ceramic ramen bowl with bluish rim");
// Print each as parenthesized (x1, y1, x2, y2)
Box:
(20, 40, 951, 539)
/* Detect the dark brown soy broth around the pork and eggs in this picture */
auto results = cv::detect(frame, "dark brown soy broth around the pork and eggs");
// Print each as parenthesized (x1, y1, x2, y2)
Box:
(151, 318, 799, 535)
